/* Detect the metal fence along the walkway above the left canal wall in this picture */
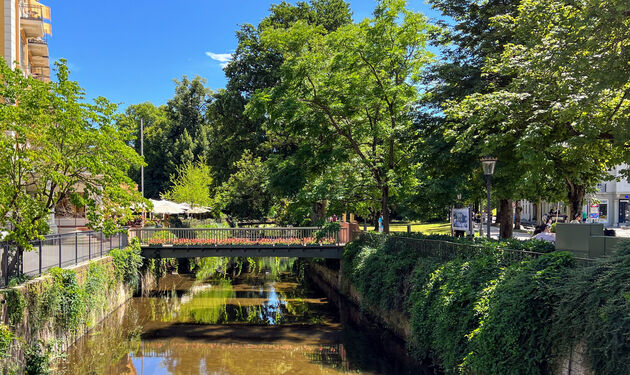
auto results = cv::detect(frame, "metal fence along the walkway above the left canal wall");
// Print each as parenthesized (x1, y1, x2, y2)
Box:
(0, 231, 128, 286)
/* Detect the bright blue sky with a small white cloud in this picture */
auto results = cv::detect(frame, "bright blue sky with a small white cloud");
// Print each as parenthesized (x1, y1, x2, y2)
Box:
(47, 0, 437, 108)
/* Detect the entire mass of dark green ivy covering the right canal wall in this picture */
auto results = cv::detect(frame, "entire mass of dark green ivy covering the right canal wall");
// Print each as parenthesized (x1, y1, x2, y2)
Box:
(343, 234, 630, 375)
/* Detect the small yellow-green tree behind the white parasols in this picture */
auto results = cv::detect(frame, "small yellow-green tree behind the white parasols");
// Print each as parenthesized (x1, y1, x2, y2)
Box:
(163, 157, 213, 207)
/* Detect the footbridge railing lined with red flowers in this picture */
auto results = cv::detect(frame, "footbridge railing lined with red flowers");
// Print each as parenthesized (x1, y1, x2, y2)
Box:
(129, 227, 347, 246)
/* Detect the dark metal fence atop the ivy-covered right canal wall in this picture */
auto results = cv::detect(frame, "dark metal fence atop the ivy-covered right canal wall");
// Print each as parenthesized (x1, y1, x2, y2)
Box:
(390, 236, 595, 266)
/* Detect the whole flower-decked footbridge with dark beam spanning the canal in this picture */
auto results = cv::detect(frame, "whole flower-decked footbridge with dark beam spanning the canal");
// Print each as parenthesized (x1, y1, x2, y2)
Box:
(129, 227, 350, 259)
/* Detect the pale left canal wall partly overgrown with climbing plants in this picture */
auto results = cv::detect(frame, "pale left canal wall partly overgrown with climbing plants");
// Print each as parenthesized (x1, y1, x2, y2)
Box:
(0, 244, 142, 374)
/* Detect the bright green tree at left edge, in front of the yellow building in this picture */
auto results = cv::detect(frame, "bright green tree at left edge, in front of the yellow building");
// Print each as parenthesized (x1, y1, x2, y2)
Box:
(0, 60, 142, 251)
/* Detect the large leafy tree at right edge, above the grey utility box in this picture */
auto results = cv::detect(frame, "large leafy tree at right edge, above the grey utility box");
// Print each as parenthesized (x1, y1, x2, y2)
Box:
(446, 0, 630, 220)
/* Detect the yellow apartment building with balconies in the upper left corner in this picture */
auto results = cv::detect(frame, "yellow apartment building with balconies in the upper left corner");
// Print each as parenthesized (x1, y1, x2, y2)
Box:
(0, 0, 52, 81)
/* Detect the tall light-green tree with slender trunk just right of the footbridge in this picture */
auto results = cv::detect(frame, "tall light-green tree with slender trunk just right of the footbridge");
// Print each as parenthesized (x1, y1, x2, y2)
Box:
(249, 1, 430, 231)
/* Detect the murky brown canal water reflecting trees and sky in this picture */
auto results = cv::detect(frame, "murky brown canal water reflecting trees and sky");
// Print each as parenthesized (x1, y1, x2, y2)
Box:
(57, 260, 432, 375)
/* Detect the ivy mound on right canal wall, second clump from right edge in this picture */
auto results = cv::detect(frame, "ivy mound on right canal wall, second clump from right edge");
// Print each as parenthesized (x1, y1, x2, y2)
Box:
(462, 253, 574, 374)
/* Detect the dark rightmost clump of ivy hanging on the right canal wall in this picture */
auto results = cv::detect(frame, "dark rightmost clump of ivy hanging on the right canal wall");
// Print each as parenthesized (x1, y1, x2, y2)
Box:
(552, 241, 630, 375)
